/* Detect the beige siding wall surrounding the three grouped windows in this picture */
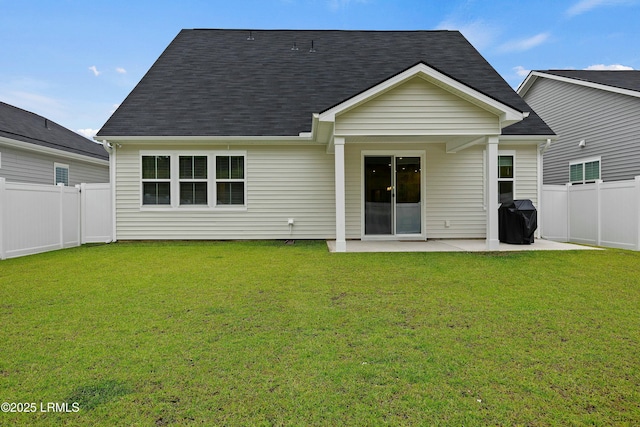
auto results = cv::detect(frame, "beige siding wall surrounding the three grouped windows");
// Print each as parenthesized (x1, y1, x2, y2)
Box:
(116, 145, 335, 240)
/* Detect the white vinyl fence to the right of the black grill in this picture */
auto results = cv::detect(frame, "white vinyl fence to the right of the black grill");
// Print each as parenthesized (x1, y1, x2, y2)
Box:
(541, 176, 640, 251)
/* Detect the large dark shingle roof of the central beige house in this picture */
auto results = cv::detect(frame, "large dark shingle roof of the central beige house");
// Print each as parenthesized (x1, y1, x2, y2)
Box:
(98, 29, 553, 136)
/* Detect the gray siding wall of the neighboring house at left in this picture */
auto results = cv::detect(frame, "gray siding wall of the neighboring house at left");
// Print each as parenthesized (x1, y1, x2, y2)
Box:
(0, 144, 109, 186)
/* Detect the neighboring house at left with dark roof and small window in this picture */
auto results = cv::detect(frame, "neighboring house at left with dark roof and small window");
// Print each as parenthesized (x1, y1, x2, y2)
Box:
(0, 102, 109, 186)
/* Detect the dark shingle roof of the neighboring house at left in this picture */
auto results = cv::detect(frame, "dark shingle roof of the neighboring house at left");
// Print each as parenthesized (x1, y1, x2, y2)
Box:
(0, 102, 109, 160)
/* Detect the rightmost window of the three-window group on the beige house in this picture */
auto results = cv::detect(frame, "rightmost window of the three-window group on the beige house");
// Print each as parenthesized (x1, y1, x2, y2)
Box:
(216, 156, 245, 205)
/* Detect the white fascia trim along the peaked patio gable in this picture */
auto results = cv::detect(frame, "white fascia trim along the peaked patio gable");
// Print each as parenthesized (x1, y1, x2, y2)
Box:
(319, 64, 528, 126)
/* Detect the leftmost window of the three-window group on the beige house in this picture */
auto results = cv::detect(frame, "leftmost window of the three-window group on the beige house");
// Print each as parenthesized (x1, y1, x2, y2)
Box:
(142, 156, 171, 205)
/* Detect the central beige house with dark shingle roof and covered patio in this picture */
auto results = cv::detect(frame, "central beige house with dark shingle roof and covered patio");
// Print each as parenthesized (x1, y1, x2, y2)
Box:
(96, 30, 554, 251)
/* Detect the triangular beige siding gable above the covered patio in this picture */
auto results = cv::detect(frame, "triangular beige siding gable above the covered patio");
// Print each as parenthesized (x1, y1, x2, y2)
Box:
(335, 77, 500, 136)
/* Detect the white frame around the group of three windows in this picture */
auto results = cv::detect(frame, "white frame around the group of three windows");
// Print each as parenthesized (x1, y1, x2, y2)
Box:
(138, 150, 248, 211)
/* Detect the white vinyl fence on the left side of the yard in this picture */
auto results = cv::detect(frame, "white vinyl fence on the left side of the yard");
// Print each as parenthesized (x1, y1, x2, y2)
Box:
(0, 178, 111, 259)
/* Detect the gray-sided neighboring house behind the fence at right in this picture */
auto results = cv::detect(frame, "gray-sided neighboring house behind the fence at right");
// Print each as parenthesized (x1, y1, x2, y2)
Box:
(518, 70, 640, 184)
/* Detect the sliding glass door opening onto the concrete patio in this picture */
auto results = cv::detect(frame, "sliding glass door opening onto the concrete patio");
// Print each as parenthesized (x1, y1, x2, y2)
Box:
(364, 156, 422, 236)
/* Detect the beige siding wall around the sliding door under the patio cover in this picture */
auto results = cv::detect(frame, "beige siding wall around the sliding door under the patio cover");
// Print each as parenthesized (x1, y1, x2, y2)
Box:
(345, 141, 538, 239)
